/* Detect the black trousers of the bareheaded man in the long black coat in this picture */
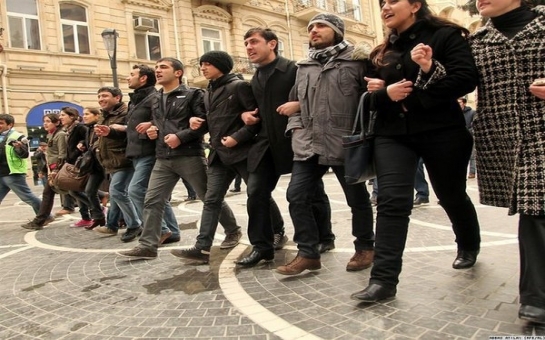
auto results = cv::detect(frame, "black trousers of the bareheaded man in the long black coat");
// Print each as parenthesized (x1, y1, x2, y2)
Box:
(246, 150, 284, 253)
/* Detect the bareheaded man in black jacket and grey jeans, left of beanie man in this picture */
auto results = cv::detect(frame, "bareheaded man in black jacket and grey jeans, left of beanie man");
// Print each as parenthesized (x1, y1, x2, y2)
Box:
(118, 58, 240, 259)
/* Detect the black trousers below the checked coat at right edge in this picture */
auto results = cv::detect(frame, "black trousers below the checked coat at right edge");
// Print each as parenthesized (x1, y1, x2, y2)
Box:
(519, 215, 545, 309)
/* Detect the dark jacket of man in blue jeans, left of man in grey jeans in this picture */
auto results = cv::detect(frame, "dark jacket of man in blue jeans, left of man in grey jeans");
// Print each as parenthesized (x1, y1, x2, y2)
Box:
(126, 86, 157, 158)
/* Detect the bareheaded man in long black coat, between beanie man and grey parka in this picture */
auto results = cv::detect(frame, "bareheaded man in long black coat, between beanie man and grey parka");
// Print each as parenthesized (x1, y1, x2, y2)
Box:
(237, 28, 335, 266)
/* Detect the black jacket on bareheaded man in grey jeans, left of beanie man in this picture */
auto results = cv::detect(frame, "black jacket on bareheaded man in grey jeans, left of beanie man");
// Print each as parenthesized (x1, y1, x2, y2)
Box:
(151, 84, 206, 158)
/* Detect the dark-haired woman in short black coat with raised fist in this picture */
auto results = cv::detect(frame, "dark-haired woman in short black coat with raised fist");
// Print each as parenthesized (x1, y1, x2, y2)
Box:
(352, 0, 480, 302)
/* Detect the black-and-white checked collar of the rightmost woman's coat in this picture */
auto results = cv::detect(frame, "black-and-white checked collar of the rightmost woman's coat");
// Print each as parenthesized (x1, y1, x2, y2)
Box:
(470, 6, 545, 43)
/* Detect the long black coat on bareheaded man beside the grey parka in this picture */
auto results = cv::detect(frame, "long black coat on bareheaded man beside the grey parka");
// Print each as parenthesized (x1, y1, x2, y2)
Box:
(248, 57, 297, 175)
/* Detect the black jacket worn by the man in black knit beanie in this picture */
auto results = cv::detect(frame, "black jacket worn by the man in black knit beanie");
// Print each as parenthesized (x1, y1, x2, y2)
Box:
(204, 74, 259, 165)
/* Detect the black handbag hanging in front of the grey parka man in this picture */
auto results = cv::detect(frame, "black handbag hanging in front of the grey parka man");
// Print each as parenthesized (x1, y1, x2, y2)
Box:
(342, 92, 377, 184)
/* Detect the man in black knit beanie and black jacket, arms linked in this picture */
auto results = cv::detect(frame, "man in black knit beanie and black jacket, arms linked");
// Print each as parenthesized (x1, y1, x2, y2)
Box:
(171, 51, 259, 263)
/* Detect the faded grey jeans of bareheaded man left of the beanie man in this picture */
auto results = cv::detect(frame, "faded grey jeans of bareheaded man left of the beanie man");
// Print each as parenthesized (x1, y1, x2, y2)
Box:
(139, 156, 240, 250)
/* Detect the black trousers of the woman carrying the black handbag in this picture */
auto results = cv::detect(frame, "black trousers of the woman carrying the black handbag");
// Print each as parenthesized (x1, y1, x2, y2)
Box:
(370, 127, 481, 287)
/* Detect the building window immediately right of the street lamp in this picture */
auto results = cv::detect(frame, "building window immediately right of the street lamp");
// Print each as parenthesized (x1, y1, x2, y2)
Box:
(133, 16, 162, 60)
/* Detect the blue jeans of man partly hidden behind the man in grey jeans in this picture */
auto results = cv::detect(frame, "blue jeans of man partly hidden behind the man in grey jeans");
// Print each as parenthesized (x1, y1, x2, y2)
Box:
(129, 155, 180, 236)
